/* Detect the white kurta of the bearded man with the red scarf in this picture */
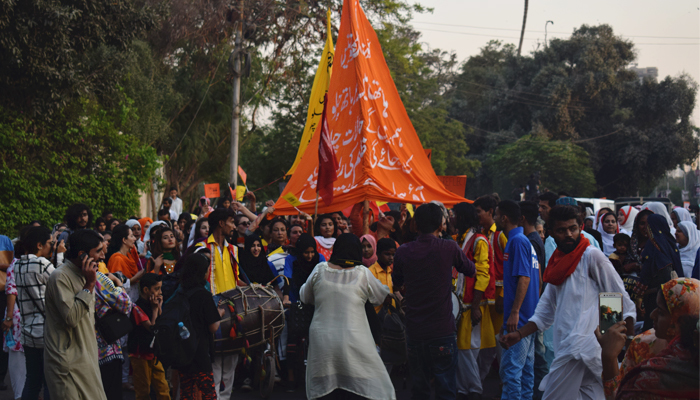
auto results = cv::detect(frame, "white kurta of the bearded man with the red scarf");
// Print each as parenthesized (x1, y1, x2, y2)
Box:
(530, 246, 637, 394)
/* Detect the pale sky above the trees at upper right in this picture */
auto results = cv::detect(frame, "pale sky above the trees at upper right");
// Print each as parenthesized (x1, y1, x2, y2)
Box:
(409, 0, 700, 126)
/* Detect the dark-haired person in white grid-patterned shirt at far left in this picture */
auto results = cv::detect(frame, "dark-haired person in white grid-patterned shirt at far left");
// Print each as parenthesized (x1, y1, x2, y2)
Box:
(14, 227, 54, 400)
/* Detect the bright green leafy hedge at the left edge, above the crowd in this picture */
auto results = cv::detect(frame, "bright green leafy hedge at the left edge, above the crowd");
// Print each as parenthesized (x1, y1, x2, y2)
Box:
(0, 101, 157, 235)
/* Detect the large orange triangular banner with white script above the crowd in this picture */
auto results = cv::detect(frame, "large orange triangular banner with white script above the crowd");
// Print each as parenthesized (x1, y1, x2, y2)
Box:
(275, 0, 467, 215)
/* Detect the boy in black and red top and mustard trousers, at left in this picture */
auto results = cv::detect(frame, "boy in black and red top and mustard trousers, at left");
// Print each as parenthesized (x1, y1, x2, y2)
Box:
(128, 273, 170, 400)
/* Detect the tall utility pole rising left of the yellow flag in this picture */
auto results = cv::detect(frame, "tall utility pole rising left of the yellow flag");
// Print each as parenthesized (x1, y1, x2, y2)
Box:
(229, 0, 244, 188)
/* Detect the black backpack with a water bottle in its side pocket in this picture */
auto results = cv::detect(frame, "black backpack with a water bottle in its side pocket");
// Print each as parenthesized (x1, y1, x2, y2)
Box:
(153, 287, 202, 369)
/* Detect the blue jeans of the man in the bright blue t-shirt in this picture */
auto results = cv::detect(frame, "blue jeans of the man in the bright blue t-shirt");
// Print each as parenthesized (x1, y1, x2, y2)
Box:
(500, 335, 535, 400)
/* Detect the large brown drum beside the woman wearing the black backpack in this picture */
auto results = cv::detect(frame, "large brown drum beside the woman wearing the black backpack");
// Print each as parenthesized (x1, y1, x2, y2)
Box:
(214, 284, 285, 354)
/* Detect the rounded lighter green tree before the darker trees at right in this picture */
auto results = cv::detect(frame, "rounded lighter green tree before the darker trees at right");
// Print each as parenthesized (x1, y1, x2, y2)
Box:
(486, 135, 595, 197)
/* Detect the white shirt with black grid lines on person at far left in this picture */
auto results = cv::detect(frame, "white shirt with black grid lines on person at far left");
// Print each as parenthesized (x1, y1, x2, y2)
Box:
(15, 254, 55, 348)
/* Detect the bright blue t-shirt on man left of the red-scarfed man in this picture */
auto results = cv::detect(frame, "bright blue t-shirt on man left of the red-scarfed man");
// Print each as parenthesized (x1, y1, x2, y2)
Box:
(503, 228, 540, 328)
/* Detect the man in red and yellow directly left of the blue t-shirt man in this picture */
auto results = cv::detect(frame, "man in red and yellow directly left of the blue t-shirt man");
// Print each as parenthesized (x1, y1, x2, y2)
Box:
(474, 195, 508, 382)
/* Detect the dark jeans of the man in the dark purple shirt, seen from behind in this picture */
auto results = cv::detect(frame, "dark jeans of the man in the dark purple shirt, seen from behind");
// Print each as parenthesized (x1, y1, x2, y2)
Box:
(408, 335, 457, 400)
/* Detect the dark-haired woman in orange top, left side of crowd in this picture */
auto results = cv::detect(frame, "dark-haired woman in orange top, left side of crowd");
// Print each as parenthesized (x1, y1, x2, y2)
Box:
(106, 224, 144, 290)
